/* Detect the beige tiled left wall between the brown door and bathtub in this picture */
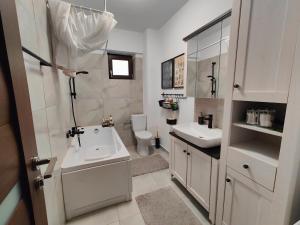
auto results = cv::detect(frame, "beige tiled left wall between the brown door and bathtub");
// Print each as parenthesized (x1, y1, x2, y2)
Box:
(16, 0, 71, 225)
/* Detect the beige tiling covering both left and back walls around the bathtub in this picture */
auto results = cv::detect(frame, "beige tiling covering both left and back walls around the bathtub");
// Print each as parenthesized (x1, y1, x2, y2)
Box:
(15, 0, 143, 225)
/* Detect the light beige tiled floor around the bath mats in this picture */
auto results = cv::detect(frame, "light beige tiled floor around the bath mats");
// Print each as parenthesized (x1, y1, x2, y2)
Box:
(67, 147, 210, 225)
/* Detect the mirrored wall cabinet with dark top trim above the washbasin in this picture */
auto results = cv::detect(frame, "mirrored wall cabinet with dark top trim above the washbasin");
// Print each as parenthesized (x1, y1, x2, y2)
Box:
(184, 11, 231, 98)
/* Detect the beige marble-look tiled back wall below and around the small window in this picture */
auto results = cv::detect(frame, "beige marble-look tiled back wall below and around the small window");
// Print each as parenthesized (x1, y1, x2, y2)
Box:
(75, 54, 143, 146)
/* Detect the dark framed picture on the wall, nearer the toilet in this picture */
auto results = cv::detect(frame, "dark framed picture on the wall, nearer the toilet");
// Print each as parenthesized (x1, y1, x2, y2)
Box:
(161, 59, 174, 89)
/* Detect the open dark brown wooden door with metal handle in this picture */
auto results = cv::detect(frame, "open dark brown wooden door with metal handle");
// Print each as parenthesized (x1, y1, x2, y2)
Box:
(0, 0, 48, 225)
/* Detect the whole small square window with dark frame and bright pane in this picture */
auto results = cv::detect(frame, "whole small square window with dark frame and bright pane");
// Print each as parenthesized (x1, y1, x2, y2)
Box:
(108, 54, 133, 80)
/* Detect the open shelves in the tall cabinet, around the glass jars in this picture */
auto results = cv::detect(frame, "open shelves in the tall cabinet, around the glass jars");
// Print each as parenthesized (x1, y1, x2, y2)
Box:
(229, 101, 286, 164)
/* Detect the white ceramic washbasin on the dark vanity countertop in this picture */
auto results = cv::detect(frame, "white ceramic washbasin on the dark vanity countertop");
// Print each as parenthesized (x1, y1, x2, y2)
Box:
(173, 122, 222, 148)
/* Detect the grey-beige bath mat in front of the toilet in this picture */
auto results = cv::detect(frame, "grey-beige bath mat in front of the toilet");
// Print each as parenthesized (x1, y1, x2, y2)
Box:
(131, 154, 169, 177)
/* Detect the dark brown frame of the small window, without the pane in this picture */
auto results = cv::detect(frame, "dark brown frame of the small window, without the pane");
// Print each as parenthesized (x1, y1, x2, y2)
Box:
(108, 53, 134, 80)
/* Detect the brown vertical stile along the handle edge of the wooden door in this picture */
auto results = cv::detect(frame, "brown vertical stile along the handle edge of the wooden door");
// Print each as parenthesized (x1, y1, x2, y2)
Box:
(0, 0, 48, 225)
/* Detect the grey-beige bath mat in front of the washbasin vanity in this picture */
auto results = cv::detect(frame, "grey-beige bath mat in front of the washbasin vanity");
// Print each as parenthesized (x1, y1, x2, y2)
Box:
(135, 187, 202, 225)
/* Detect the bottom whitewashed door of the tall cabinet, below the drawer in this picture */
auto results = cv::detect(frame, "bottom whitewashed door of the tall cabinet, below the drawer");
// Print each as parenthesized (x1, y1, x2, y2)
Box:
(222, 168, 272, 225)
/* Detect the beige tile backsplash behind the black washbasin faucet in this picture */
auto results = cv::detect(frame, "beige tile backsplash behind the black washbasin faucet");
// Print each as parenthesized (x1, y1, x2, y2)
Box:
(195, 98, 224, 128)
